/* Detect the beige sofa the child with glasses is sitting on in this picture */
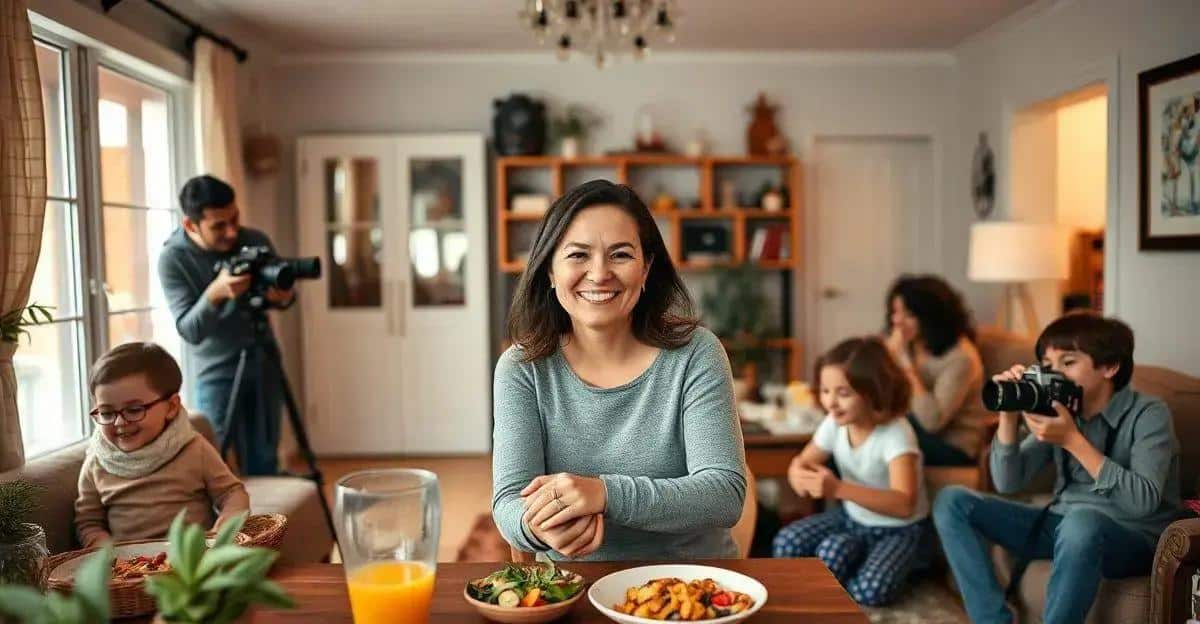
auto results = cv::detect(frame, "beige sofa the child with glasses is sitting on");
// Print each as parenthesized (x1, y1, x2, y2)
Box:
(0, 414, 334, 563)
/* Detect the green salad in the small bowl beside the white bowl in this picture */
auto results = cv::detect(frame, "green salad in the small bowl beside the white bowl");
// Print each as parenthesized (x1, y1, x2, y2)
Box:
(467, 563, 583, 607)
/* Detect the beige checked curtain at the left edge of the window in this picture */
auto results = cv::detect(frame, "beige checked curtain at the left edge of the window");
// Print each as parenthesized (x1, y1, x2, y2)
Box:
(0, 0, 46, 472)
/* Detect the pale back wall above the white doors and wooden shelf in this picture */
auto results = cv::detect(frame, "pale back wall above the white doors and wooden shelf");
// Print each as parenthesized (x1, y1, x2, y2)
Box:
(265, 52, 954, 372)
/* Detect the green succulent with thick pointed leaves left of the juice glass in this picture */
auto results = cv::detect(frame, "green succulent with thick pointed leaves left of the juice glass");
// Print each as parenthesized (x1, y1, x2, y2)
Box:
(146, 511, 294, 624)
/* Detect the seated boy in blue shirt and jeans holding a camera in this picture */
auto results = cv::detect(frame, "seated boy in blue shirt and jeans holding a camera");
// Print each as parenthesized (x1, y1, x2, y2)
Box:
(934, 313, 1180, 624)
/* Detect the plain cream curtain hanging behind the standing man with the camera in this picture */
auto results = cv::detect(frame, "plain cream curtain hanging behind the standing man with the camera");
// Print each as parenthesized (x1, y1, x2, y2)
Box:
(192, 37, 246, 218)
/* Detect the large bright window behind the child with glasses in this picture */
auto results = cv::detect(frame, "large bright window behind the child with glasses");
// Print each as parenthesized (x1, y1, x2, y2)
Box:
(13, 34, 185, 457)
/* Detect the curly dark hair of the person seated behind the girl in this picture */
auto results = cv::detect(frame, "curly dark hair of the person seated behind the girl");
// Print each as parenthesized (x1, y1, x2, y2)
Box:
(883, 275, 974, 355)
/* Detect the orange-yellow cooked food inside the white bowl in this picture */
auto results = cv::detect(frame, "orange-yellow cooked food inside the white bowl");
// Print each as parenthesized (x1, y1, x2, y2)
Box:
(613, 578, 754, 622)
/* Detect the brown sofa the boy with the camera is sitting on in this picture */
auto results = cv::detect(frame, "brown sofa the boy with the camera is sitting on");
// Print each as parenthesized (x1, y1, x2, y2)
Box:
(945, 329, 1200, 624)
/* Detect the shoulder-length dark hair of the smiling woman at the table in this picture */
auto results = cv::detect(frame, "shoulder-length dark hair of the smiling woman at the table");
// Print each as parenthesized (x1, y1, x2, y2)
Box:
(509, 180, 700, 361)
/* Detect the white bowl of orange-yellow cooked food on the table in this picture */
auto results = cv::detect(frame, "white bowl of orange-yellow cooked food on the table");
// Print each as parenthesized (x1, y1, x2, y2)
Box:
(588, 564, 767, 624)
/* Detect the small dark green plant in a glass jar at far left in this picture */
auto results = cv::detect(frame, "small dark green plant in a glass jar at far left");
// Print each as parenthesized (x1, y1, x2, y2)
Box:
(0, 479, 49, 589)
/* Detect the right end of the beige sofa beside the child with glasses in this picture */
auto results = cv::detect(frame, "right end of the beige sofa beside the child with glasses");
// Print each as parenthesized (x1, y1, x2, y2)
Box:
(244, 476, 334, 563)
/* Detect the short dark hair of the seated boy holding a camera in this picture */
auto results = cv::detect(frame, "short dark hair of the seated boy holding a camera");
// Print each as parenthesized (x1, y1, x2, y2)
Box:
(1033, 312, 1133, 392)
